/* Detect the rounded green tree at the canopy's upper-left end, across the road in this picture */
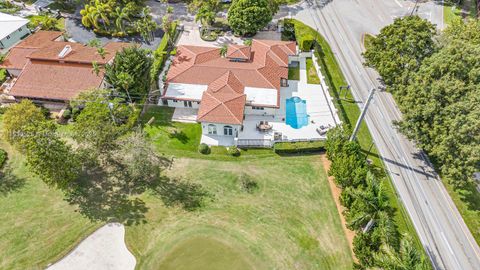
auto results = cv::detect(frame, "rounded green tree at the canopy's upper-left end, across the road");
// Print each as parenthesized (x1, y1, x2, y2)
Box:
(363, 16, 436, 88)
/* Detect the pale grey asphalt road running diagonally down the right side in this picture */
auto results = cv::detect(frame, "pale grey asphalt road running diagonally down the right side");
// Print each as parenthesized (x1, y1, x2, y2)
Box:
(281, 0, 480, 270)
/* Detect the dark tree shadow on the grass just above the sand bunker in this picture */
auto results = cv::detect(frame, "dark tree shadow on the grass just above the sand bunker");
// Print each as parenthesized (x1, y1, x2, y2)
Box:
(65, 170, 208, 225)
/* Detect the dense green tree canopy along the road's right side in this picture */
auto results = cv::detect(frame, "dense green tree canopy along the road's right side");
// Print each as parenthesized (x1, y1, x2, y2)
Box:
(365, 17, 480, 186)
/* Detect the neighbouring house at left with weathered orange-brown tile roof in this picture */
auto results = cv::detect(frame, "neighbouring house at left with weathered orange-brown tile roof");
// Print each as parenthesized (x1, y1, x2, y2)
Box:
(0, 31, 131, 104)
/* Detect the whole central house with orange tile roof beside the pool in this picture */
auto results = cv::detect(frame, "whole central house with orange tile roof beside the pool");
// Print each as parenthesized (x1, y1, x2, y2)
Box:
(162, 40, 297, 143)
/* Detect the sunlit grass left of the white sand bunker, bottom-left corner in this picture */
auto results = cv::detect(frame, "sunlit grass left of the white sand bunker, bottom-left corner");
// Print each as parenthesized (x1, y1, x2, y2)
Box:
(0, 116, 101, 269)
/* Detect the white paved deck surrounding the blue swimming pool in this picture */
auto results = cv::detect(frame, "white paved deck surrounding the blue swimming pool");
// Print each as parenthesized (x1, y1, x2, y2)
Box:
(238, 58, 340, 140)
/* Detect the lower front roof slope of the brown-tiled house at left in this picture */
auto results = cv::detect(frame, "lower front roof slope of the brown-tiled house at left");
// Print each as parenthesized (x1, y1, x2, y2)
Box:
(10, 61, 103, 101)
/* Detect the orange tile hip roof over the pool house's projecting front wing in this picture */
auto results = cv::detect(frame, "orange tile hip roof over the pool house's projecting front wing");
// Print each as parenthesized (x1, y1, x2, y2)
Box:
(197, 71, 246, 125)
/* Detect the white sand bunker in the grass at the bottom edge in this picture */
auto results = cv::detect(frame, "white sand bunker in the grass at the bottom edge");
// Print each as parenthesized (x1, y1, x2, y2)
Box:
(47, 223, 136, 270)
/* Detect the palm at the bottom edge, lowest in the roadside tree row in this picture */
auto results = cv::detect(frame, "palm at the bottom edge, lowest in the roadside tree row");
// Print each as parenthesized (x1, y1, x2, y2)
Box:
(374, 235, 429, 270)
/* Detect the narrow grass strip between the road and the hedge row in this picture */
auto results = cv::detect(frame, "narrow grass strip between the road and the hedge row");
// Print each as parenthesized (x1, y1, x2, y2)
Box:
(284, 20, 423, 250)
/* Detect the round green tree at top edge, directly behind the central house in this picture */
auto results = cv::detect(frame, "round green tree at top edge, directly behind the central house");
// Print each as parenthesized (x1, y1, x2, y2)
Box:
(228, 0, 273, 35)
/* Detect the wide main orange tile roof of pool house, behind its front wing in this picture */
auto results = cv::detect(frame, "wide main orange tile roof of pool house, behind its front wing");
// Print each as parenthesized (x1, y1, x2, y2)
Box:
(167, 40, 296, 90)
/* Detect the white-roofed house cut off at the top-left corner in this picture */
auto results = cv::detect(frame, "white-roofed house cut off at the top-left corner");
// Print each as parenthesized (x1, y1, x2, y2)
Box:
(0, 12, 30, 50)
